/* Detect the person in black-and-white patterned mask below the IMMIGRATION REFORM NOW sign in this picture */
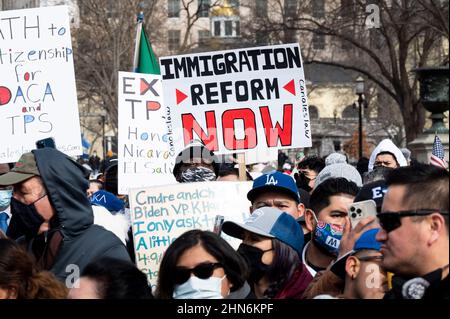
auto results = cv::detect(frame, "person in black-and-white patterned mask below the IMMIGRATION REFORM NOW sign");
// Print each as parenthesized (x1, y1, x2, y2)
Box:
(173, 141, 219, 183)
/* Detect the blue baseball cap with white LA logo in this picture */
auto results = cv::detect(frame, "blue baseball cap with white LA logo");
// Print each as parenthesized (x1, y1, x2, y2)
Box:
(247, 171, 300, 203)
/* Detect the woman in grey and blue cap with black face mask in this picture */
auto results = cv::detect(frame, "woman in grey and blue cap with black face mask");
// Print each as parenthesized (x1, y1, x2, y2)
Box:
(222, 207, 313, 299)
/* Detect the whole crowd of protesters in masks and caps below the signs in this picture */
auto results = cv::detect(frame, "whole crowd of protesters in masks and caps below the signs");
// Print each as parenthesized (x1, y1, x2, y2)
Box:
(0, 140, 449, 299)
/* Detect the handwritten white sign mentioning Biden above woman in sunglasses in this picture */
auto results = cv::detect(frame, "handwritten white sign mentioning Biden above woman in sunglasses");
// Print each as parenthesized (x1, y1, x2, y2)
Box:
(129, 182, 252, 288)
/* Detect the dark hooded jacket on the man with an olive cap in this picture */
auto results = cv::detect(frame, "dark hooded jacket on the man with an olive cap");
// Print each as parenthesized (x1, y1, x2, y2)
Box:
(30, 148, 130, 280)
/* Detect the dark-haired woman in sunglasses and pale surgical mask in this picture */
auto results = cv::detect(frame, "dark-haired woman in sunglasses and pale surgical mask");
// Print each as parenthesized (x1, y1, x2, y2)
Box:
(156, 230, 250, 299)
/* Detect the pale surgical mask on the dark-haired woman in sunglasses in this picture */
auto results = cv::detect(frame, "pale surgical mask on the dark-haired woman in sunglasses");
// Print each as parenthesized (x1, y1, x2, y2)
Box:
(172, 275, 226, 299)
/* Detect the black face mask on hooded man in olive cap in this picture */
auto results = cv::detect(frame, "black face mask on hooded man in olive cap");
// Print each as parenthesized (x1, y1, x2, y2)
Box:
(8, 197, 45, 238)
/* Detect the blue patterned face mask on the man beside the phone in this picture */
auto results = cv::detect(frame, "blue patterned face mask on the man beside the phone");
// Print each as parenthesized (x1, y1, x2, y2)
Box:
(313, 214, 344, 256)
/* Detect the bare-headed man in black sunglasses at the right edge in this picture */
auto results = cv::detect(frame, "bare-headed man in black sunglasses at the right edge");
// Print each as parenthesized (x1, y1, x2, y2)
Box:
(376, 164, 450, 299)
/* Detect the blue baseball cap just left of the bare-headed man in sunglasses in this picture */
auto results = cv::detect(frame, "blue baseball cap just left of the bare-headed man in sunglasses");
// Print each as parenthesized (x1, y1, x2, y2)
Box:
(331, 228, 381, 279)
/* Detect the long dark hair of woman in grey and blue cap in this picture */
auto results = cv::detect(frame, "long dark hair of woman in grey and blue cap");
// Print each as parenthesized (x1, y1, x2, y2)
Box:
(264, 238, 302, 299)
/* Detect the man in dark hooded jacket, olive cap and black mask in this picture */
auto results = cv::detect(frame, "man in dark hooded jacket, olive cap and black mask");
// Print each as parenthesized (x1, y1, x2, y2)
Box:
(0, 148, 129, 280)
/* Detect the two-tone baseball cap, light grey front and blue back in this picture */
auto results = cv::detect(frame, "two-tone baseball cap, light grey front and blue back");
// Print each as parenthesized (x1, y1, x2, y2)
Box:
(222, 207, 304, 256)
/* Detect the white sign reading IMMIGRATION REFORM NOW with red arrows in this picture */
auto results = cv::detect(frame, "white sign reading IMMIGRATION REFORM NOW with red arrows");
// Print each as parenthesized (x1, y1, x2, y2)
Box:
(160, 44, 311, 154)
